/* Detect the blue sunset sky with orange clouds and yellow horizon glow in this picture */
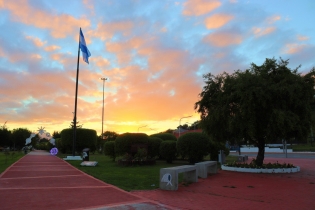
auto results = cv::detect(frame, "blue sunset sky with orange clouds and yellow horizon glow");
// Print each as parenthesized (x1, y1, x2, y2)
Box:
(0, 0, 315, 135)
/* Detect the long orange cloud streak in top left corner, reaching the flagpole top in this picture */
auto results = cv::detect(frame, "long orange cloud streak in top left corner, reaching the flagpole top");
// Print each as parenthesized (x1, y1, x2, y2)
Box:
(0, 0, 90, 38)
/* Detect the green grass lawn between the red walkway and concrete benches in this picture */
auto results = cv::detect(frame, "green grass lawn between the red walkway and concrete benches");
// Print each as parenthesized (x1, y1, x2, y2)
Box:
(63, 154, 237, 191)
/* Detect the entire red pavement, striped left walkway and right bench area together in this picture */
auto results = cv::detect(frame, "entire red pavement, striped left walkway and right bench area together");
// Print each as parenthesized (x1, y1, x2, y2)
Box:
(0, 152, 315, 210)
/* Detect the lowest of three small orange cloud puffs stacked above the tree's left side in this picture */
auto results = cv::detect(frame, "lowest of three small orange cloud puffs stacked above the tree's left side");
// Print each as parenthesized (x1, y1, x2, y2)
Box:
(203, 32, 242, 47)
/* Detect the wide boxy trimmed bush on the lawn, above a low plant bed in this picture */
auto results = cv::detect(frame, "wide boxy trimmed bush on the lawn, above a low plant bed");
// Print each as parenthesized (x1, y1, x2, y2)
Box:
(115, 133, 149, 156)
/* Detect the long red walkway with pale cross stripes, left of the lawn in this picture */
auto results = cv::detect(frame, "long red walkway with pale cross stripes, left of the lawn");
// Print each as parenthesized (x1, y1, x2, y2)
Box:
(0, 151, 172, 210)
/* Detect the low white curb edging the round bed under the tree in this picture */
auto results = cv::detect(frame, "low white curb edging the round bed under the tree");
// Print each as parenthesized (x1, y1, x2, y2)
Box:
(221, 165, 300, 173)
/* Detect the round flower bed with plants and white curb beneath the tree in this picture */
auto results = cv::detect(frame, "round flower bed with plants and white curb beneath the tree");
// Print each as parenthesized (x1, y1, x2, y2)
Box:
(221, 159, 300, 173)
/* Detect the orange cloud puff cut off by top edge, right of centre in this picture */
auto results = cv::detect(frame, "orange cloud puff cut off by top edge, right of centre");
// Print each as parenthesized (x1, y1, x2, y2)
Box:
(183, 0, 221, 16)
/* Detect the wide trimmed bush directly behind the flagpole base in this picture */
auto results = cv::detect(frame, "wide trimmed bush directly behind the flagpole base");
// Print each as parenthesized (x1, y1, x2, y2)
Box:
(61, 128, 97, 154)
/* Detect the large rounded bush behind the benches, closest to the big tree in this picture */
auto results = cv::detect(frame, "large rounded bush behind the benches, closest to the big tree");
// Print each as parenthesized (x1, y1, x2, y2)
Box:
(177, 132, 209, 164)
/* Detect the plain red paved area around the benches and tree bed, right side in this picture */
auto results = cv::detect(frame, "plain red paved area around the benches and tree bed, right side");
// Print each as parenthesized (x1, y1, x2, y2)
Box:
(132, 158, 315, 210)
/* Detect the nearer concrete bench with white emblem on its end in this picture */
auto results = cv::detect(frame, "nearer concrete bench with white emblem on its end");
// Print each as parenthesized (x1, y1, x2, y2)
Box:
(160, 165, 198, 190)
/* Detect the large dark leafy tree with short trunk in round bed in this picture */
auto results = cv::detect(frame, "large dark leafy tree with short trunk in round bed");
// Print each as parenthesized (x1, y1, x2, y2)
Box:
(195, 58, 315, 165)
